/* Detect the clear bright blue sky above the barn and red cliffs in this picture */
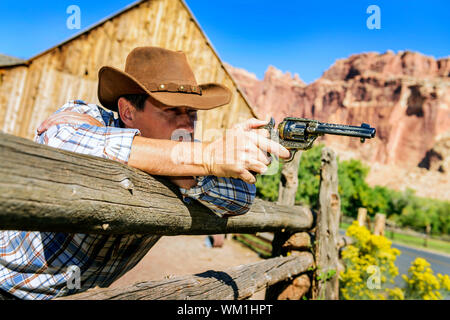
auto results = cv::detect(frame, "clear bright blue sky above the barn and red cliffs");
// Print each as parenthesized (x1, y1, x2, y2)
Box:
(0, 0, 450, 83)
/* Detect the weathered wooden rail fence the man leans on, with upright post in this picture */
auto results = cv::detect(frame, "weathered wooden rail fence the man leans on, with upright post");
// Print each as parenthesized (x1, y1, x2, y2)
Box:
(0, 133, 339, 299)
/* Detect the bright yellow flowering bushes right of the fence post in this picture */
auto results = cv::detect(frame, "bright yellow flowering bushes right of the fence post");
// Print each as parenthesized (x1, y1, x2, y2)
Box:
(339, 221, 450, 300)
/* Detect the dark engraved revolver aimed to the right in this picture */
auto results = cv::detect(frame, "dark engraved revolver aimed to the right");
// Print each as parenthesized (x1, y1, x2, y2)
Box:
(260, 117, 376, 162)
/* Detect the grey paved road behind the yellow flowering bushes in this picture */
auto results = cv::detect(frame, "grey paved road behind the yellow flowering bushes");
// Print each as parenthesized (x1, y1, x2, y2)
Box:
(340, 230, 450, 300)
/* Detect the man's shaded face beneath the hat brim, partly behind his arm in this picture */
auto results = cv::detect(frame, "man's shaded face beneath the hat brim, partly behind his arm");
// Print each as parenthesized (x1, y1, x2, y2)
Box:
(133, 98, 197, 141)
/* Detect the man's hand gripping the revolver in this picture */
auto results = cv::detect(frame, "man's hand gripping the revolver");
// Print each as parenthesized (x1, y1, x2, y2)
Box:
(203, 118, 290, 183)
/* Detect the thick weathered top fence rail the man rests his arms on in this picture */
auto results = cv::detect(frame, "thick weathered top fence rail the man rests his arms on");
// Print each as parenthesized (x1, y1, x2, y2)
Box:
(0, 133, 313, 236)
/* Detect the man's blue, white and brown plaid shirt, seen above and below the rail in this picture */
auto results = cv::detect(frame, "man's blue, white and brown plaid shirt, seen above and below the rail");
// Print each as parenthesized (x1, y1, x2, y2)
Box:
(0, 100, 255, 299)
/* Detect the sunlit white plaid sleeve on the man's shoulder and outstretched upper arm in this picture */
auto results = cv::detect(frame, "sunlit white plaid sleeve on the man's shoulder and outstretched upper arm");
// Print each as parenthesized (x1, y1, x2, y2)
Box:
(35, 100, 140, 164)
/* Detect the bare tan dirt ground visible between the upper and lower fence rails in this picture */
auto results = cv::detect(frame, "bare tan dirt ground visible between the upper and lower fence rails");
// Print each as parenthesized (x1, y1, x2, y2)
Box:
(110, 235, 264, 299)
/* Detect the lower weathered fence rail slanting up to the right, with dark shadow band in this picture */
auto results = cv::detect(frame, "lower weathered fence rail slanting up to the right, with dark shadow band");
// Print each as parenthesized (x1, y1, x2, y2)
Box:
(60, 252, 314, 300)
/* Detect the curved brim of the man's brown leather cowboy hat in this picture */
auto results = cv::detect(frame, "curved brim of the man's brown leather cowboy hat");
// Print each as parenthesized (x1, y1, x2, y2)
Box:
(98, 66, 231, 112)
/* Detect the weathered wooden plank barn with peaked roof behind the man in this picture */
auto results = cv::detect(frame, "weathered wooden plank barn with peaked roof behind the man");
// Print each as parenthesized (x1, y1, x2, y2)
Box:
(0, 0, 255, 140)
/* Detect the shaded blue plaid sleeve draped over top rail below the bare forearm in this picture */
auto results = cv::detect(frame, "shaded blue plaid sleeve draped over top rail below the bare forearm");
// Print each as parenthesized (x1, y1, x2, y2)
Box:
(180, 176, 256, 217)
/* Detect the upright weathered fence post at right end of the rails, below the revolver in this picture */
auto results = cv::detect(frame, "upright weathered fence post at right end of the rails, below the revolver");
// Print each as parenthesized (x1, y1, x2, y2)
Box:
(312, 147, 341, 300)
